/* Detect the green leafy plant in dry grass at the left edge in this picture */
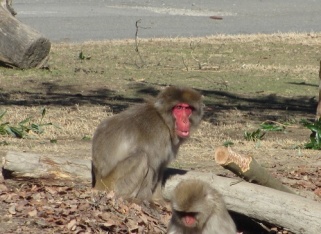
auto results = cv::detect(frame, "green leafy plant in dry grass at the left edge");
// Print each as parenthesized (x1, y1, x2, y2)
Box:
(0, 108, 53, 138)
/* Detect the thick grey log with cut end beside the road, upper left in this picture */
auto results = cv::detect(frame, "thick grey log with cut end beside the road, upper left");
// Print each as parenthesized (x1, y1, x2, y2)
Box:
(0, 0, 51, 69)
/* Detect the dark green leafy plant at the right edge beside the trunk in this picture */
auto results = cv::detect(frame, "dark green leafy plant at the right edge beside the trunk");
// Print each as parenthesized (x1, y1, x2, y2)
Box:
(300, 119, 321, 150)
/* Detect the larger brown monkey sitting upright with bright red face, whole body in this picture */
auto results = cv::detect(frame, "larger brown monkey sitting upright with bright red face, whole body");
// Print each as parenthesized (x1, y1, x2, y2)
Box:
(92, 87, 203, 200)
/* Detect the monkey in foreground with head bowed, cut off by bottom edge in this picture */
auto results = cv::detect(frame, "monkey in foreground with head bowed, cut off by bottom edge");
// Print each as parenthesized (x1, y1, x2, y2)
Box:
(167, 180, 237, 234)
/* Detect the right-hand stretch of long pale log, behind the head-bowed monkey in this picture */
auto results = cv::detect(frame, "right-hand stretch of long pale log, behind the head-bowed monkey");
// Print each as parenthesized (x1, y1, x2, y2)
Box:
(163, 170, 321, 234)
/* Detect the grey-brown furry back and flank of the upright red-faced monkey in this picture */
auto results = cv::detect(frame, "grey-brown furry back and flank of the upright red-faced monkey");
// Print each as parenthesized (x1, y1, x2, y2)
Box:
(92, 103, 174, 179)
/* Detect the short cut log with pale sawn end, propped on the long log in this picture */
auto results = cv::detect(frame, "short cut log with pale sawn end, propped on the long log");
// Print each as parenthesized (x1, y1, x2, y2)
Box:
(214, 146, 294, 193)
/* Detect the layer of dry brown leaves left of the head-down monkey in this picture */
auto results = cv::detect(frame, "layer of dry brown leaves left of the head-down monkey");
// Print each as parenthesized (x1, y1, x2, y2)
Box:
(0, 176, 170, 233)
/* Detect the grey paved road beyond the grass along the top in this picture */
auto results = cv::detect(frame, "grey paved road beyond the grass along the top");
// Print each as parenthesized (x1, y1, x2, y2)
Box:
(13, 0, 321, 42)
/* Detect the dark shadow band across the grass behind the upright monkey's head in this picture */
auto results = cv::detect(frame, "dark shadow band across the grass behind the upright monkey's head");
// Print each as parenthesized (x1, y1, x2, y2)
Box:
(0, 82, 317, 119)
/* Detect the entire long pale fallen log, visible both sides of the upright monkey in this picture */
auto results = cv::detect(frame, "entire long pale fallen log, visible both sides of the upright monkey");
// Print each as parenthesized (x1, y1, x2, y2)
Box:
(2, 152, 321, 234)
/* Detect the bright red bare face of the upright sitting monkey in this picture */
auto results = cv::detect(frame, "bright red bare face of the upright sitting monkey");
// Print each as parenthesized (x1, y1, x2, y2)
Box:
(172, 103, 193, 138)
